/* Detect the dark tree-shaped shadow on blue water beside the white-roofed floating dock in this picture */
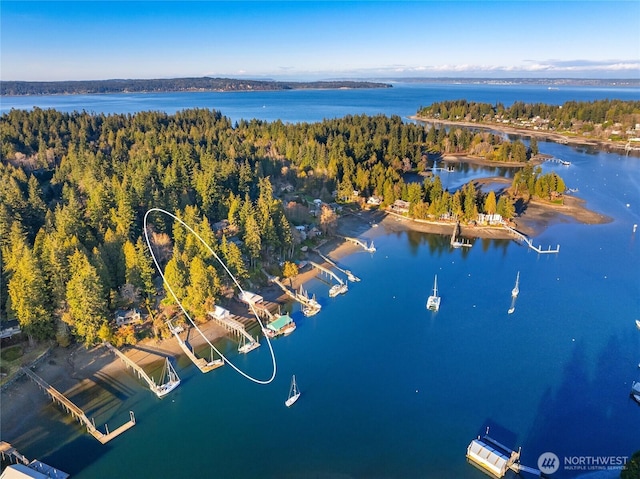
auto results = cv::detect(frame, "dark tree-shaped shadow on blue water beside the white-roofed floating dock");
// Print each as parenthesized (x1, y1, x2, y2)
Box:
(522, 336, 640, 478)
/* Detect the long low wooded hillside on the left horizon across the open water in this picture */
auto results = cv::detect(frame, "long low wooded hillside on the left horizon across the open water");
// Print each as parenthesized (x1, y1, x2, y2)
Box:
(0, 77, 391, 96)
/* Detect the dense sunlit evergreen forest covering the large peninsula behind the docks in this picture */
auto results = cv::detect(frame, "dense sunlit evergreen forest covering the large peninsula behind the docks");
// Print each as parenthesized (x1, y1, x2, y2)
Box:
(0, 98, 626, 352)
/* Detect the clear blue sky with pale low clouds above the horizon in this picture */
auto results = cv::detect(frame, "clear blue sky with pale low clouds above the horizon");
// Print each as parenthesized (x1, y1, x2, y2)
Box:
(0, 0, 640, 81)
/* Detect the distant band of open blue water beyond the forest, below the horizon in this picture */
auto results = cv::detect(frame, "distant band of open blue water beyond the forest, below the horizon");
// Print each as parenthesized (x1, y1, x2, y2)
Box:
(0, 83, 640, 123)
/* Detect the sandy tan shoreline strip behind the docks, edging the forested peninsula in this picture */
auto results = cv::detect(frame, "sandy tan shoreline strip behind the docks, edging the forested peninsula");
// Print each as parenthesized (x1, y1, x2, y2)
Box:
(0, 178, 612, 452)
